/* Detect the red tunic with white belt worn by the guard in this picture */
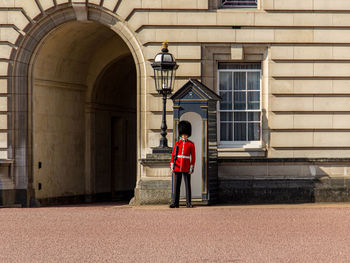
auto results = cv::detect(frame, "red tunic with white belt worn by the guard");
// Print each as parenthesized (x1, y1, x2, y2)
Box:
(170, 139, 196, 173)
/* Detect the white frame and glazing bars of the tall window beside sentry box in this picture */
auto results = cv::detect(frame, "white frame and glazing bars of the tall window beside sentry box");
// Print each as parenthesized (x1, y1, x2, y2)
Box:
(217, 69, 263, 148)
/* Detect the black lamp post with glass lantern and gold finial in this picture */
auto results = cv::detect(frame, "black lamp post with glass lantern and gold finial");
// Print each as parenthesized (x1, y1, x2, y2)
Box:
(152, 41, 179, 153)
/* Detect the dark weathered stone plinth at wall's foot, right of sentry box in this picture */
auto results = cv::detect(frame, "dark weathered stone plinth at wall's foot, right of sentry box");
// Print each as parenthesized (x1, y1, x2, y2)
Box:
(219, 178, 350, 204)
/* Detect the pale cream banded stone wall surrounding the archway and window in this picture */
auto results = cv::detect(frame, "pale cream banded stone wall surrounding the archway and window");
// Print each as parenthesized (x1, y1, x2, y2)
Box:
(0, 0, 349, 160)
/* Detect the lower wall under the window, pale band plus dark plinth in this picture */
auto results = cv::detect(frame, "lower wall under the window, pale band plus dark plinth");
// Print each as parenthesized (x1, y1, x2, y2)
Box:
(219, 158, 350, 203)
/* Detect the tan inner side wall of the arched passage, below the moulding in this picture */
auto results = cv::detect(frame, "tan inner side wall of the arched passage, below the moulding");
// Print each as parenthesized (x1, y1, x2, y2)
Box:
(33, 81, 85, 199)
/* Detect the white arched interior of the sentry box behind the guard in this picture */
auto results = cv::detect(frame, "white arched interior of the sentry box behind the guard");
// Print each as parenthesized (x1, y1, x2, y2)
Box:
(180, 112, 203, 199)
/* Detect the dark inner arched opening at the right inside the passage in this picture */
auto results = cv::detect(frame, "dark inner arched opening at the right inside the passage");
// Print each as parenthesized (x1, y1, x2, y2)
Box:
(93, 54, 136, 201)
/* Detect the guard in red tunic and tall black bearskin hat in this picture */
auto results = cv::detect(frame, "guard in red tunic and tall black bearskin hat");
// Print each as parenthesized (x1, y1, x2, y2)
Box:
(169, 121, 196, 208)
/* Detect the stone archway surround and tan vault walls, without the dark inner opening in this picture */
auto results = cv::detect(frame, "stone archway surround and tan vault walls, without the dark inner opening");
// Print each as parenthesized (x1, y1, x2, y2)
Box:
(11, 5, 144, 205)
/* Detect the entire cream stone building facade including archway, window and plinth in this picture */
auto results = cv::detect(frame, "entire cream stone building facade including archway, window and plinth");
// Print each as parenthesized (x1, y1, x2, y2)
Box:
(0, 0, 350, 206)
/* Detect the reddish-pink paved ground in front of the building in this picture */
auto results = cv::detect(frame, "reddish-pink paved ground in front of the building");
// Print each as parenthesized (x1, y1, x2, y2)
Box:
(0, 204, 350, 263)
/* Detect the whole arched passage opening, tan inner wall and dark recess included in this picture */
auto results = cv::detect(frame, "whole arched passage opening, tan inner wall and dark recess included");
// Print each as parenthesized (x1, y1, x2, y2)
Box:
(30, 21, 137, 204)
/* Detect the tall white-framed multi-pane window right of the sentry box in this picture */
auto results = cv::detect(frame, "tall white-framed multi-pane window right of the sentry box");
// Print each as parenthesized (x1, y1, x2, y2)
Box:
(218, 63, 261, 147)
